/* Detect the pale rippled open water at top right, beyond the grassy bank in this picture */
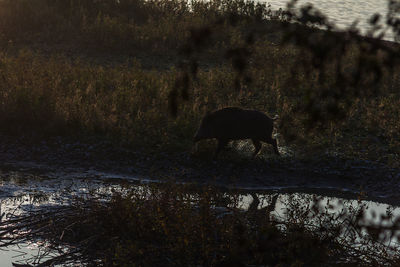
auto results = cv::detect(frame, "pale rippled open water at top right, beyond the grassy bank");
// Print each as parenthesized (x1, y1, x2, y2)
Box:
(262, 0, 393, 40)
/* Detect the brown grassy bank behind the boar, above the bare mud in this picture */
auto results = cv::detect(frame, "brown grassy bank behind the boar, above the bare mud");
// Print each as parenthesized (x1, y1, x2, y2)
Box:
(0, 0, 400, 166)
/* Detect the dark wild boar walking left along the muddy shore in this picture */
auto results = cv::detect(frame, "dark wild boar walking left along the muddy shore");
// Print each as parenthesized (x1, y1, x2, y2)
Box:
(194, 107, 279, 158)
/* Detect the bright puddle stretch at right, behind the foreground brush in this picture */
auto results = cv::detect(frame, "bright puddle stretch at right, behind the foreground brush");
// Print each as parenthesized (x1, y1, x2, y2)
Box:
(240, 193, 400, 248)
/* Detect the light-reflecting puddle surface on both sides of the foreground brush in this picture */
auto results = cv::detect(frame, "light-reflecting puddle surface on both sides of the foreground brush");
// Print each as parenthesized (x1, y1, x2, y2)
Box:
(0, 179, 400, 266)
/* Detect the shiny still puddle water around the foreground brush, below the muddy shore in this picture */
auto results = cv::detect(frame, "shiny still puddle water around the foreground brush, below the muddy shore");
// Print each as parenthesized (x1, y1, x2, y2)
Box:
(0, 179, 400, 267)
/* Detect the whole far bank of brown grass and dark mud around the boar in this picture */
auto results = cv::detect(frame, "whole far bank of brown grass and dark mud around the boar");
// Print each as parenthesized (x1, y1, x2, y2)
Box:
(0, 0, 400, 204)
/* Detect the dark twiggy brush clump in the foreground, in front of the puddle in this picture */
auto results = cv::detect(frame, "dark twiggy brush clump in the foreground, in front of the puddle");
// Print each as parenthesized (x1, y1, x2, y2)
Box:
(0, 184, 399, 266)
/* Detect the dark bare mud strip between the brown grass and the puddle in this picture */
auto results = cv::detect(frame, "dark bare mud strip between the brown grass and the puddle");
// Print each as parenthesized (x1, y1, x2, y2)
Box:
(0, 137, 400, 205)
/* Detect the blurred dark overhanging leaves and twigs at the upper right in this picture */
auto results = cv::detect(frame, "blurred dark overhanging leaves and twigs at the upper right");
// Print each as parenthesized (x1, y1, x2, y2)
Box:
(171, 0, 400, 133)
